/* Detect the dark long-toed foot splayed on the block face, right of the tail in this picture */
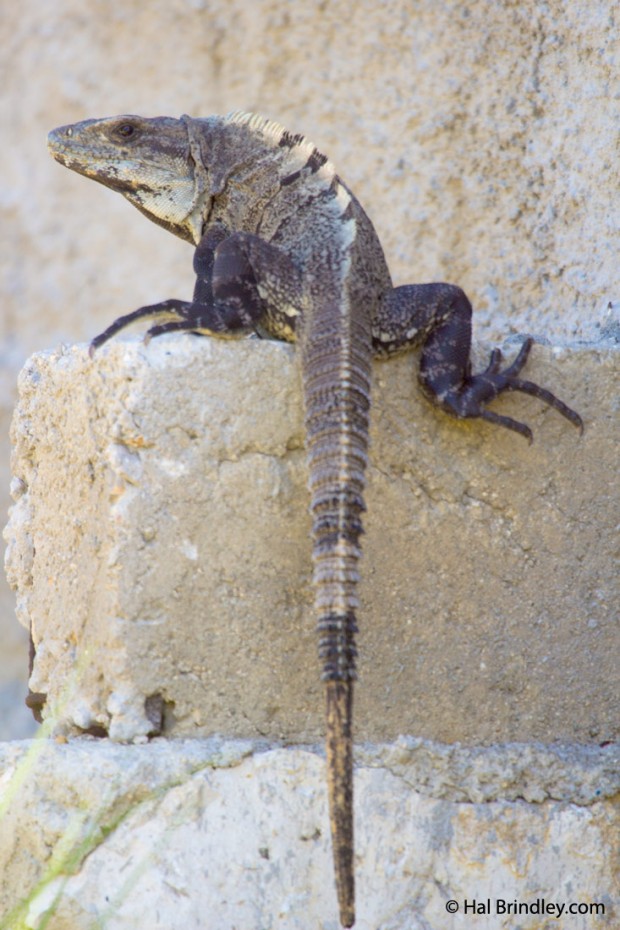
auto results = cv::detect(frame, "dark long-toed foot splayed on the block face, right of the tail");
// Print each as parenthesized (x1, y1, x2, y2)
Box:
(422, 336, 583, 443)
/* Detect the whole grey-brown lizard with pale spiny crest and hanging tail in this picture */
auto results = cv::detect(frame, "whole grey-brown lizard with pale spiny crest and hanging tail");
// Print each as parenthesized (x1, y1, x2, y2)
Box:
(49, 113, 582, 927)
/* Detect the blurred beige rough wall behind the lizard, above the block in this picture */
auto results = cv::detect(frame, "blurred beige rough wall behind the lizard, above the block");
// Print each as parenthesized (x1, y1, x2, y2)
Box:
(0, 0, 620, 738)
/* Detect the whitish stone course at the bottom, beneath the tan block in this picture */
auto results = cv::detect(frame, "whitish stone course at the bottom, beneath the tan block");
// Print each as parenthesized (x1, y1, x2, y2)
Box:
(0, 739, 619, 930)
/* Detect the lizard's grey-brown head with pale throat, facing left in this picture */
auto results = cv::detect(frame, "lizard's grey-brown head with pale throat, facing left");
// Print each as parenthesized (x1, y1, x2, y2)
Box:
(47, 116, 205, 242)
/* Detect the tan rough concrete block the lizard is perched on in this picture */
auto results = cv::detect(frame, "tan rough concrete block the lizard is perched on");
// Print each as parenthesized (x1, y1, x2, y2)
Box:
(6, 336, 620, 743)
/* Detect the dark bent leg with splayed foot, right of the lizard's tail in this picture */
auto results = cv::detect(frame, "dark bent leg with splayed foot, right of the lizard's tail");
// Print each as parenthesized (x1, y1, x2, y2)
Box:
(373, 284, 583, 442)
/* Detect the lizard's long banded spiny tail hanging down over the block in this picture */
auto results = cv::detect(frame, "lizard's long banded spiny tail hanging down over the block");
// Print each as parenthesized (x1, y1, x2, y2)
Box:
(302, 288, 371, 927)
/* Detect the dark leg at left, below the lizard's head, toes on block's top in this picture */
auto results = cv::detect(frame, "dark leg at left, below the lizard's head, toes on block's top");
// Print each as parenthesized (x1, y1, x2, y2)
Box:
(90, 227, 301, 355)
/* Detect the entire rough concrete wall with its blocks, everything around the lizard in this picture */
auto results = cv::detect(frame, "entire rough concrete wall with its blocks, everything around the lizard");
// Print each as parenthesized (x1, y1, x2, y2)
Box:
(0, 0, 620, 930)
